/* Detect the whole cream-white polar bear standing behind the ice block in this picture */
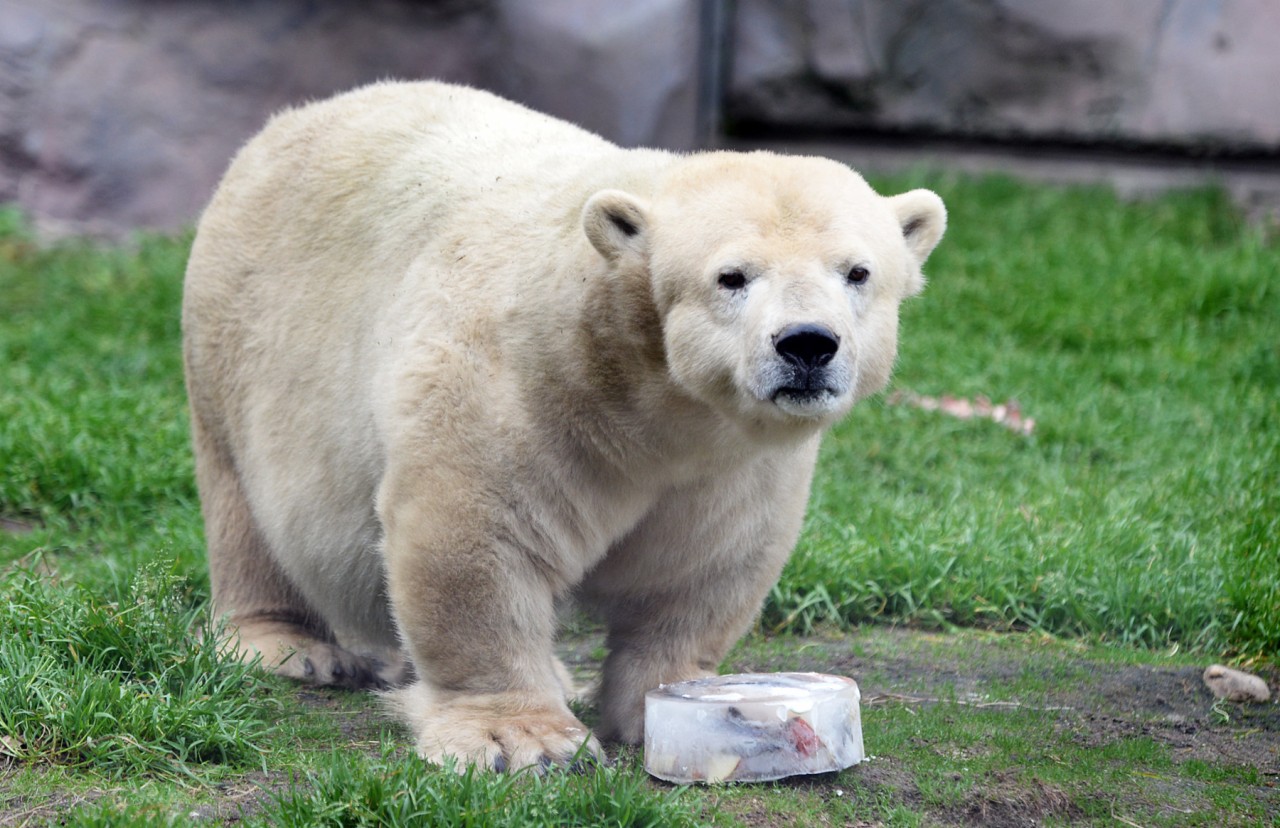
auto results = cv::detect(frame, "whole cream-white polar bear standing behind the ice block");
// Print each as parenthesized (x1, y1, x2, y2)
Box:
(183, 82, 946, 770)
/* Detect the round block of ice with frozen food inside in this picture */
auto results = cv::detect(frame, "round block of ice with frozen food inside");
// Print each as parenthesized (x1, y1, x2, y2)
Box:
(644, 673, 864, 783)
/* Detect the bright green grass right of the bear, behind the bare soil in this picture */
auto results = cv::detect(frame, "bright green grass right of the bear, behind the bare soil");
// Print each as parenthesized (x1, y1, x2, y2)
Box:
(765, 179, 1280, 655)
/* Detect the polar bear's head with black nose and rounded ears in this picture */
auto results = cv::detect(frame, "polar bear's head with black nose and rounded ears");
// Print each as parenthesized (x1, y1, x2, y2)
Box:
(584, 152, 946, 425)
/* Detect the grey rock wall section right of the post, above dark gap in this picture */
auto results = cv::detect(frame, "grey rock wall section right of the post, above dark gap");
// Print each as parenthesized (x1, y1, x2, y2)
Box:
(726, 0, 1280, 154)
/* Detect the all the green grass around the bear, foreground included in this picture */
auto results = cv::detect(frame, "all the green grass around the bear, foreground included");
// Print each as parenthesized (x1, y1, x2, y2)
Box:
(0, 177, 1280, 825)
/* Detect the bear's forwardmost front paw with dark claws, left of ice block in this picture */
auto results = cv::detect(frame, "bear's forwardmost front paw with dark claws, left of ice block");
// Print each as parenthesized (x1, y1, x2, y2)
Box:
(387, 682, 604, 773)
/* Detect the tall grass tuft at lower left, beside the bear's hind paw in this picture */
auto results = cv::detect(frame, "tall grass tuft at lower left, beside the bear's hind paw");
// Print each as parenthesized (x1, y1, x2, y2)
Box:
(0, 563, 268, 777)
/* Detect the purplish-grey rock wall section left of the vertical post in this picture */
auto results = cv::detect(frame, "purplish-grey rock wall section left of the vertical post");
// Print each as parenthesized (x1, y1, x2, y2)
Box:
(0, 0, 698, 235)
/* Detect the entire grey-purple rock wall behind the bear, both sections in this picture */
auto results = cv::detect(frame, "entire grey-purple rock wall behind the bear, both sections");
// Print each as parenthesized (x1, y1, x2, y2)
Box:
(0, 0, 1280, 235)
